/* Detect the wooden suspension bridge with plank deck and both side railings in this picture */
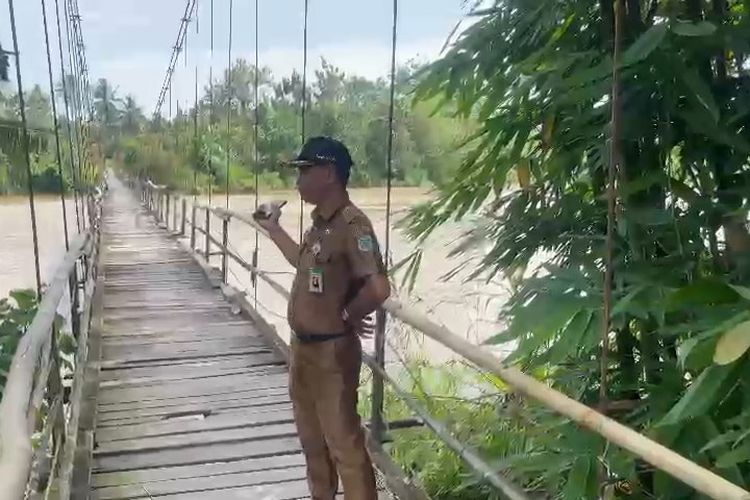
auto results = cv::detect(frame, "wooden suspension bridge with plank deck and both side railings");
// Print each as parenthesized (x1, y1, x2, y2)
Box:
(0, 178, 750, 500)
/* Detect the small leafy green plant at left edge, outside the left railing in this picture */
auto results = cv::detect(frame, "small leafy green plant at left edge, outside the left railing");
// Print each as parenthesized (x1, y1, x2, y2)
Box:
(0, 290, 38, 398)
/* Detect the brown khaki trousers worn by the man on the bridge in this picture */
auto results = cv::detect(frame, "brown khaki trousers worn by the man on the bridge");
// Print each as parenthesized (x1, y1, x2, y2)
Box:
(289, 335, 377, 500)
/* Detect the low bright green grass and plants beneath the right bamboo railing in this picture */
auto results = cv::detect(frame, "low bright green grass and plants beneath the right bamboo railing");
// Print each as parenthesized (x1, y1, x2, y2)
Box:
(360, 361, 635, 500)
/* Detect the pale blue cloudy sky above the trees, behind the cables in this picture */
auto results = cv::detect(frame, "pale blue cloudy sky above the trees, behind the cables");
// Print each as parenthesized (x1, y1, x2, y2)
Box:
(0, 0, 466, 114)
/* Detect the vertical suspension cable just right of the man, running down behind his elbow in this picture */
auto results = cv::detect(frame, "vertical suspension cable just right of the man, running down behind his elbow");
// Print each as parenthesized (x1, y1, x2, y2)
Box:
(371, 0, 398, 442)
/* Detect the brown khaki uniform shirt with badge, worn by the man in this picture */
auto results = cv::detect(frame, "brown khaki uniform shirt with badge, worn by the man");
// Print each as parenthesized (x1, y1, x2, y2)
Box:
(287, 199, 385, 335)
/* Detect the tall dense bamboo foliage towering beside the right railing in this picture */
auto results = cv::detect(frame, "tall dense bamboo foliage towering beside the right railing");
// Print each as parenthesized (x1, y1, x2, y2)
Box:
(401, 0, 750, 499)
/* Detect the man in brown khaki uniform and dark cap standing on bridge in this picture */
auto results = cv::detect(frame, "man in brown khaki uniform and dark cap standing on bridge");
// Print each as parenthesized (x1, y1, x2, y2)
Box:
(260, 137, 390, 500)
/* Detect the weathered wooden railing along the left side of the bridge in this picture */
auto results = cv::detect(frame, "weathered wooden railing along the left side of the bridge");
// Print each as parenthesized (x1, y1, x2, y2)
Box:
(0, 194, 101, 500)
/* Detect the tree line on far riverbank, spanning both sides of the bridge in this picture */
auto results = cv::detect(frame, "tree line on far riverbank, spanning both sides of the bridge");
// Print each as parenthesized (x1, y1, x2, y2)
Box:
(0, 58, 473, 194)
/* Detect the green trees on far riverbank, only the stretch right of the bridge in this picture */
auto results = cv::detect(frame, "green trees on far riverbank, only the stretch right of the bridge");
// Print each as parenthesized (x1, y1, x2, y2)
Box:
(110, 59, 473, 192)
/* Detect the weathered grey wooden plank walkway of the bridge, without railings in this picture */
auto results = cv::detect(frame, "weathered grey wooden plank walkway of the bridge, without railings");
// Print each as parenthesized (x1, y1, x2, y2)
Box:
(90, 183, 318, 500)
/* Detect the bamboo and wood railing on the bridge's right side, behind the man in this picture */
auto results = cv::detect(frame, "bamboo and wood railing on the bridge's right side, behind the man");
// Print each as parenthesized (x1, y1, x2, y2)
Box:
(131, 181, 750, 500)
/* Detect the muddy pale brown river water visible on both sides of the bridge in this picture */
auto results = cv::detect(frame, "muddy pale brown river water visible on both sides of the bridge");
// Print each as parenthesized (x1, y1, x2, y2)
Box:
(0, 188, 508, 361)
